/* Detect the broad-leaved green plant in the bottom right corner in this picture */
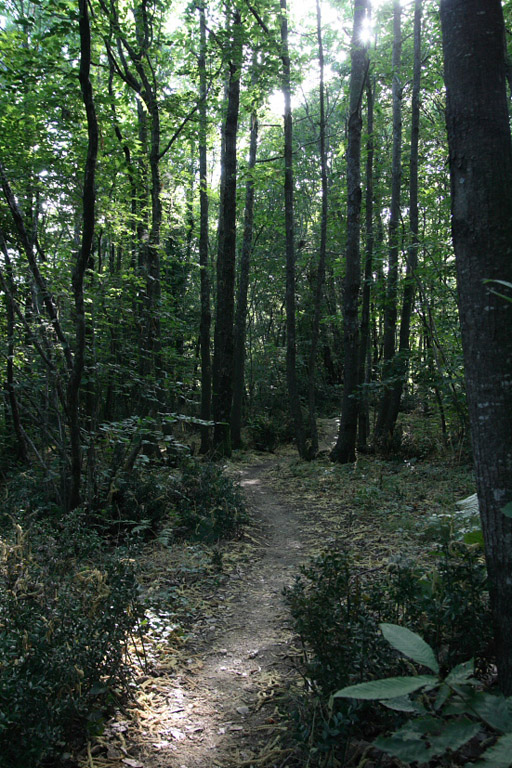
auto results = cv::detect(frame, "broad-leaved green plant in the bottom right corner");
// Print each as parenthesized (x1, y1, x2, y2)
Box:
(333, 624, 512, 768)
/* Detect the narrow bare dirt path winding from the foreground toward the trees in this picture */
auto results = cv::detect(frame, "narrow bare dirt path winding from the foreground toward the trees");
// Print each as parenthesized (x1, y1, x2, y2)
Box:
(163, 466, 308, 768)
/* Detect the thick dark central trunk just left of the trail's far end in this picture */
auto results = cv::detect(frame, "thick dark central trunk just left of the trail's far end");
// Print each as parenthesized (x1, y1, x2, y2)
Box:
(212, 10, 242, 456)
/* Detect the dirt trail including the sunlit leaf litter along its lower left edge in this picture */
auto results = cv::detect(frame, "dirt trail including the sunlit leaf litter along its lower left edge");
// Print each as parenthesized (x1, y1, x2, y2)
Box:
(110, 462, 306, 768)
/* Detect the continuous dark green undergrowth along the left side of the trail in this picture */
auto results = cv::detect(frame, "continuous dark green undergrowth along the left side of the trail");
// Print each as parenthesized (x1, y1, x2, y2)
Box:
(0, 457, 245, 768)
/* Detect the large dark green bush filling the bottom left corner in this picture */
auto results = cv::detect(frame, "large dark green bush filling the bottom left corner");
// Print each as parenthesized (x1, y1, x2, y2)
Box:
(0, 512, 140, 768)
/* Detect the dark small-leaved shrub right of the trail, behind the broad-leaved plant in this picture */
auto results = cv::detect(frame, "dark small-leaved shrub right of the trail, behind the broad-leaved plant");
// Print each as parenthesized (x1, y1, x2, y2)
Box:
(286, 541, 492, 765)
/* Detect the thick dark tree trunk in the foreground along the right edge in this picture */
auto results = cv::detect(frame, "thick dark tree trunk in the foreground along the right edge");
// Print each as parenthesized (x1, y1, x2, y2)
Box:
(441, 0, 512, 696)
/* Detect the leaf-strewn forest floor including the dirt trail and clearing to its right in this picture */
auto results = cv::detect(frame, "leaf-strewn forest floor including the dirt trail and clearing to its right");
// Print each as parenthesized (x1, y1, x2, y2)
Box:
(83, 420, 473, 768)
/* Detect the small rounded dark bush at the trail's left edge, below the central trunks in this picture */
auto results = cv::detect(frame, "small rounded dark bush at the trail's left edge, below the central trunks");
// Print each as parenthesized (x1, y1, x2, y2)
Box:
(172, 461, 246, 542)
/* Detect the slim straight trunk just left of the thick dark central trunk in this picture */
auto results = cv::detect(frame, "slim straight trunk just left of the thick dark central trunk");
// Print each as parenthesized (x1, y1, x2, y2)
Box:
(199, 0, 212, 453)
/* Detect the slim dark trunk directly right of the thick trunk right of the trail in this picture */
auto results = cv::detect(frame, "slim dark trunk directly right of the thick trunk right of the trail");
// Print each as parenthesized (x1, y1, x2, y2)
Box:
(357, 73, 375, 451)
